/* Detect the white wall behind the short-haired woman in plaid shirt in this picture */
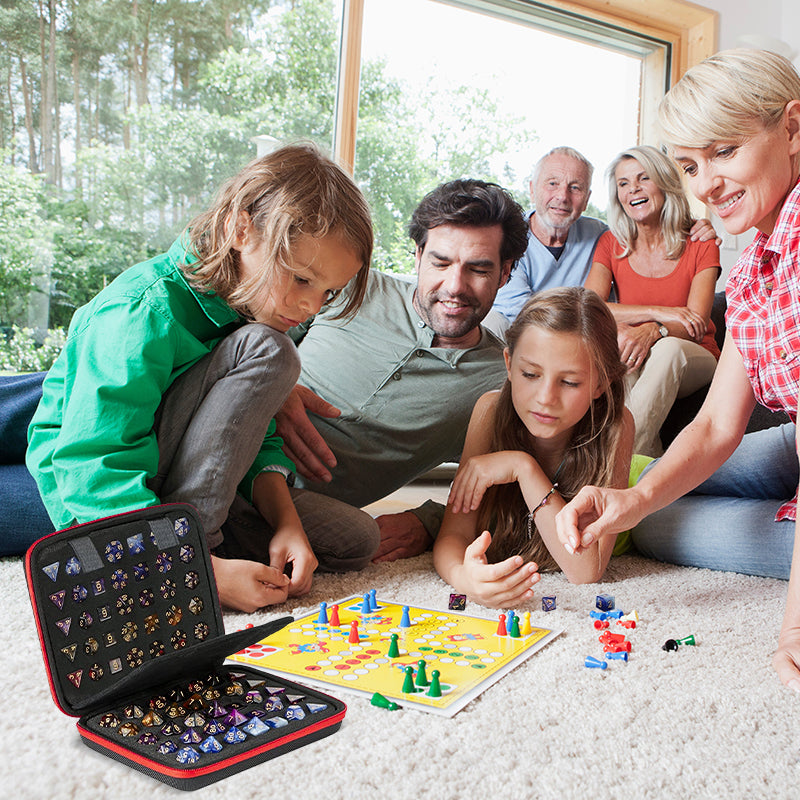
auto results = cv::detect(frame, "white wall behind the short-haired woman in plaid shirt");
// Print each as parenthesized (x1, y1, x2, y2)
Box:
(698, 0, 800, 278)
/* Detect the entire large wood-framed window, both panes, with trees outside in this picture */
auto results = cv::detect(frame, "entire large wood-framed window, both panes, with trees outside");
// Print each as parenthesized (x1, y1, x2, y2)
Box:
(0, 0, 714, 369)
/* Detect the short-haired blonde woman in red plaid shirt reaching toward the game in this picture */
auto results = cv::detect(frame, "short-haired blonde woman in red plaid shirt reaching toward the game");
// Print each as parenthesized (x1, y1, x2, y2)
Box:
(557, 50, 800, 692)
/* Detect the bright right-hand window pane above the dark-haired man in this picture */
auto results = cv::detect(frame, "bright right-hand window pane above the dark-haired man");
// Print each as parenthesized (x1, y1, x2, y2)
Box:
(355, 0, 652, 271)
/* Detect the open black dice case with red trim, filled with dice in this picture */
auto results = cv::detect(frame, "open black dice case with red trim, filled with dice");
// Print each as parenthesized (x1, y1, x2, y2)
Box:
(25, 504, 346, 789)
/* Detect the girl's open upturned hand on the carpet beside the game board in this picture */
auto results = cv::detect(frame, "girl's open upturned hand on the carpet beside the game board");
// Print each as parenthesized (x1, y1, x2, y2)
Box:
(454, 531, 539, 608)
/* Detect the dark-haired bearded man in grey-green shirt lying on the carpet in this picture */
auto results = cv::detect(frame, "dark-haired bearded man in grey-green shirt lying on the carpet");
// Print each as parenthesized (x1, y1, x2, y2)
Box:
(276, 180, 527, 558)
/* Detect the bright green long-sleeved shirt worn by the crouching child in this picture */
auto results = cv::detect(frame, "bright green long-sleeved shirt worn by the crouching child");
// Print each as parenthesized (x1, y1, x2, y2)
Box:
(26, 240, 294, 528)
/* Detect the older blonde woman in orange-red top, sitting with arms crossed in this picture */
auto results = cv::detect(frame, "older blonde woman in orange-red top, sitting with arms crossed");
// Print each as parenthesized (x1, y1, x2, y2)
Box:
(586, 146, 720, 456)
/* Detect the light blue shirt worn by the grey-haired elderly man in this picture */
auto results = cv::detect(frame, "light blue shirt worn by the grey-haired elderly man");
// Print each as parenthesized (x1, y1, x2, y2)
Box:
(492, 216, 608, 322)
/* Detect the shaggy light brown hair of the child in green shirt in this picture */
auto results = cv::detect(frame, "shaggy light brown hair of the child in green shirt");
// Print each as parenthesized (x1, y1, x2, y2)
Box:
(184, 143, 373, 317)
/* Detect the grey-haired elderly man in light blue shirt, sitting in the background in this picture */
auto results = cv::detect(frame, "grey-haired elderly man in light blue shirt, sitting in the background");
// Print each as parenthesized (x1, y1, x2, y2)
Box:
(484, 147, 717, 336)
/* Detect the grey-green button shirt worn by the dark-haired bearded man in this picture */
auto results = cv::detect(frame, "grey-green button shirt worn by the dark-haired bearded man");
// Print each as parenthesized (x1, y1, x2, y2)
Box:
(291, 270, 506, 521)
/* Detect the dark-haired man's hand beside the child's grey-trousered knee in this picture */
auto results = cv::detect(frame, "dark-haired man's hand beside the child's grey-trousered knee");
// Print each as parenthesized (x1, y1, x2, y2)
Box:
(275, 384, 342, 483)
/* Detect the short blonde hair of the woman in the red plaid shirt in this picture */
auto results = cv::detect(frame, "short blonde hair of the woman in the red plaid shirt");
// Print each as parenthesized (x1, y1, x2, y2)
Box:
(658, 48, 800, 148)
